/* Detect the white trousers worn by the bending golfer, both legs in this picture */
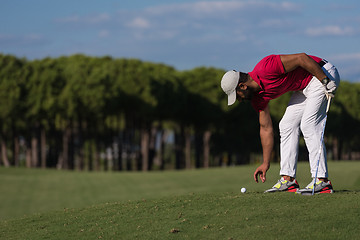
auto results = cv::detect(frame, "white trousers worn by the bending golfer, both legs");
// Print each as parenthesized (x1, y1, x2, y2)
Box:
(279, 62, 340, 178)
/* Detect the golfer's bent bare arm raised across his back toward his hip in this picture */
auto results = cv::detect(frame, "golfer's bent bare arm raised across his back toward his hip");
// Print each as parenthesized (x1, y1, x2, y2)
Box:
(280, 53, 326, 81)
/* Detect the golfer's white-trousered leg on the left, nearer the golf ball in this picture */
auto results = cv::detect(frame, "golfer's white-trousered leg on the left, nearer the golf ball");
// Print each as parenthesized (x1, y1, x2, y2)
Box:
(279, 91, 306, 178)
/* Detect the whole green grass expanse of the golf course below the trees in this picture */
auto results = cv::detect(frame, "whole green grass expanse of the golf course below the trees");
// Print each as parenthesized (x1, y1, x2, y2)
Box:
(0, 162, 360, 239)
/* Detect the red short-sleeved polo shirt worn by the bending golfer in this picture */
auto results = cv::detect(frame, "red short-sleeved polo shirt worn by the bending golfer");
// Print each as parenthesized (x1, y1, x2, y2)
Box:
(249, 55, 322, 112)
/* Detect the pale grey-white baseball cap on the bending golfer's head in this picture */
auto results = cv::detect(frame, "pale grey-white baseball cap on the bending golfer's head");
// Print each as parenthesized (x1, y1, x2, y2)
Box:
(221, 70, 240, 106)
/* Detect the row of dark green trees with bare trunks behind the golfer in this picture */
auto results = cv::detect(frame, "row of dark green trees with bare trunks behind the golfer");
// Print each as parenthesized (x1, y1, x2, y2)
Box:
(0, 54, 360, 171)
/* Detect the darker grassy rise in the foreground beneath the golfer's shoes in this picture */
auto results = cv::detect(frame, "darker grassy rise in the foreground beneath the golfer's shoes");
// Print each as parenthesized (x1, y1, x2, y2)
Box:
(0, 192, 360, 239)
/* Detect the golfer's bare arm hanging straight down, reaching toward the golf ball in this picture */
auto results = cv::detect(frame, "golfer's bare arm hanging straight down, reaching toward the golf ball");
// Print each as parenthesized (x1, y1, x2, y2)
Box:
(254, 106, 274, 182)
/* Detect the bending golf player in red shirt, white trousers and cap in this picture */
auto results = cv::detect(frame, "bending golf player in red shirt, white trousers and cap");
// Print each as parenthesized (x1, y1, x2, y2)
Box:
(221, 53, 340, 194)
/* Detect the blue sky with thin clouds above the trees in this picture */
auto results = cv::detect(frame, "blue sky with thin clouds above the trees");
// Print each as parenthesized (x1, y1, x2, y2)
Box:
(0, 0, 360, 82)
